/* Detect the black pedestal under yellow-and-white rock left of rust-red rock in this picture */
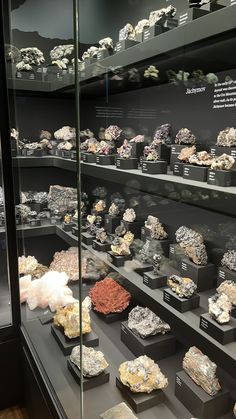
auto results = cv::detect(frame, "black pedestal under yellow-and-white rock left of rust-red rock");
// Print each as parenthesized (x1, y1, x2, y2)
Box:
(51, 324, 99, 355)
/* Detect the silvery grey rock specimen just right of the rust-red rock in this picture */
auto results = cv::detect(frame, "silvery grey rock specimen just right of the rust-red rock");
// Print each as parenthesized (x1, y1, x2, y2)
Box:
(128, 306, 170, 339)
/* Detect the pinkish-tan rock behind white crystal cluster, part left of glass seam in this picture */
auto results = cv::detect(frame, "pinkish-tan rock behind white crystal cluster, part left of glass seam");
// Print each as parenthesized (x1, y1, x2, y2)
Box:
(49, 247, 79, 281)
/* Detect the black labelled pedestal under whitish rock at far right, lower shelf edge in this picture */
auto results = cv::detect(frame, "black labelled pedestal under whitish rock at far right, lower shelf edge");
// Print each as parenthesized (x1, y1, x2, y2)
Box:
(200, 313, 236, 345)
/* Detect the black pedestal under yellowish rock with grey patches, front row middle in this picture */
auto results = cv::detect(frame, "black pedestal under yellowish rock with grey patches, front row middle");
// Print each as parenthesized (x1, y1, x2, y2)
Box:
(116, 378, 165, 413)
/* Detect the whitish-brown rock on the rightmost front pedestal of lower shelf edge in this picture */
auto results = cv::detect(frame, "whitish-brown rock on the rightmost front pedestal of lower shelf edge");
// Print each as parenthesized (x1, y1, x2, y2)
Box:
(208, 294, 232, 324)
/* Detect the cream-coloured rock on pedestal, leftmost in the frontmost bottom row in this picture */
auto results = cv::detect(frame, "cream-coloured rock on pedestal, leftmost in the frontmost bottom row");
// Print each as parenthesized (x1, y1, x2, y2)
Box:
(70, 345, 109, 377)
